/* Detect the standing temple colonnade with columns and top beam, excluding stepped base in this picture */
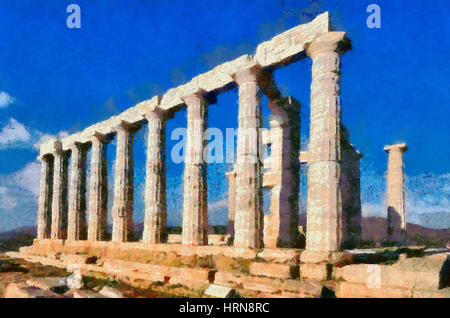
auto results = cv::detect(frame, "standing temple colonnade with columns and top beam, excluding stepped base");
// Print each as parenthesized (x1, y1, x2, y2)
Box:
(37, 13, 361, 259)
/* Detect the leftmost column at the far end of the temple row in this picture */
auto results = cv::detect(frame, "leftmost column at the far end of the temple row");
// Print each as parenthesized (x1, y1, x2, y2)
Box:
(37, 155, 53, 240)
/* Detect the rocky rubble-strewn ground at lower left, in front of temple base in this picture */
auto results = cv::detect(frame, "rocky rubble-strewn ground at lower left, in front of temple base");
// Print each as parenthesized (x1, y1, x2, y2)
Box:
(0, 254, 203, 298)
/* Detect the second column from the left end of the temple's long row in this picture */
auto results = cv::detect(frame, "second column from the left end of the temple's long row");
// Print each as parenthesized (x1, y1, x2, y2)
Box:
(50, 140, 68, 240)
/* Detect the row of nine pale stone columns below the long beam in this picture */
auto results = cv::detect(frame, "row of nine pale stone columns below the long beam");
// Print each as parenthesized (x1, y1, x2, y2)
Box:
(38, 32, 352, 255)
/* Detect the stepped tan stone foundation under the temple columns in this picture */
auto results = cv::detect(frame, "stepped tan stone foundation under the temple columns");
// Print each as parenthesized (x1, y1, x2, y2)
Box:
(8, 240, 450, 298)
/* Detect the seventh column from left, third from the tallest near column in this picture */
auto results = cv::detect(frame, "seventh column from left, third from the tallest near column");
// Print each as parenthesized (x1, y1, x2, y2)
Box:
(181, 92, 208, 245)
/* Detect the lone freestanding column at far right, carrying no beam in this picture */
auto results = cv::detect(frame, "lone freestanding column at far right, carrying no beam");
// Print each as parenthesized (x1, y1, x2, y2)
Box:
(384, 144, 408, 243)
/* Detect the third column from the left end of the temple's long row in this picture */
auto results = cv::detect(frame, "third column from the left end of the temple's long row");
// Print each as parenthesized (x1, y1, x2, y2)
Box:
(67, 142, 87, 241)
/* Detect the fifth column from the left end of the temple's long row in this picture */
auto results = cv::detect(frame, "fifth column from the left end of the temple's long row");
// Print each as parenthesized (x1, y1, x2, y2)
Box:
(112, 121, 134, 242)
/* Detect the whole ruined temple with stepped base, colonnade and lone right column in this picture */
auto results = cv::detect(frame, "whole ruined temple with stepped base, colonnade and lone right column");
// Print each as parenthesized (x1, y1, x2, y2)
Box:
(15, 13, 446, 297)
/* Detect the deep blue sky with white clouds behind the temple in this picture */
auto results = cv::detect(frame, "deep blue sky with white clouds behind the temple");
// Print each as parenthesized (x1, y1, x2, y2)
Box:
(0, 0, 450, 232)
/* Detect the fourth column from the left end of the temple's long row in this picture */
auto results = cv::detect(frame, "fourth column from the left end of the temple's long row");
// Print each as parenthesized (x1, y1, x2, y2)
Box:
(88, 133, 108, 241)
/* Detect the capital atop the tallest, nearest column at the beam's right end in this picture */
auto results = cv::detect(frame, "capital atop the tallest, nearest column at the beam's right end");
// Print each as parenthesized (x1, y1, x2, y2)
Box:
(304, 32, 351, 59)
